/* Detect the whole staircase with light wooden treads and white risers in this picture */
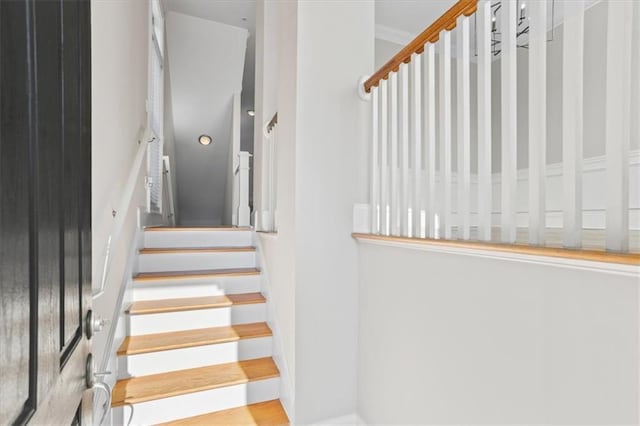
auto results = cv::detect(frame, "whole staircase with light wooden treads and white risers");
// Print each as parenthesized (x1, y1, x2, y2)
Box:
(112, 227, 289, 425)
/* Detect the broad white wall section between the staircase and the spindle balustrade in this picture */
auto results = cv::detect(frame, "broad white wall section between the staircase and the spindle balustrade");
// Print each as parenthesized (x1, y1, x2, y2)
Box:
(296, 0, 374, 424)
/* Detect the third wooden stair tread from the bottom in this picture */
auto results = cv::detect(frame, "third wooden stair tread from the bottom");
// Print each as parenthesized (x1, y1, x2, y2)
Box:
(118, 322, 272, 356)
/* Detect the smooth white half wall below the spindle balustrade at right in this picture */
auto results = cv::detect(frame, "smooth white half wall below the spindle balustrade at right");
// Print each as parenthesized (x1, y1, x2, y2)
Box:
(358, 244, 640, 425)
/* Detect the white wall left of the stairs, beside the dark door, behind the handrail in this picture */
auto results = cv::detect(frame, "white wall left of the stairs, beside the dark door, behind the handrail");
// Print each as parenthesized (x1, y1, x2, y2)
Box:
(91, 0, 149, 361)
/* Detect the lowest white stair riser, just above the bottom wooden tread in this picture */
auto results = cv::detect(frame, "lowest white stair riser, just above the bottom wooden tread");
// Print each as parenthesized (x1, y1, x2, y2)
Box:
(116, 378, 279, 425)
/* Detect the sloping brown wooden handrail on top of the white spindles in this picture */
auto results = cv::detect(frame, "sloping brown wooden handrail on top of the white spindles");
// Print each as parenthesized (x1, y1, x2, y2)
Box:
(364, 0, 478, 93)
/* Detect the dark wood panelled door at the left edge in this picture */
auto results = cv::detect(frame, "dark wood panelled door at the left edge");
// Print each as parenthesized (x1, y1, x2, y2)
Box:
(0, 0, 91, 425)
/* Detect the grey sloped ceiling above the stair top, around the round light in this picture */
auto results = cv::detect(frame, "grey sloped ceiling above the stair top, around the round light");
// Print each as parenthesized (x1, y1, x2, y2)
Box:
(166, 10, 248, 225)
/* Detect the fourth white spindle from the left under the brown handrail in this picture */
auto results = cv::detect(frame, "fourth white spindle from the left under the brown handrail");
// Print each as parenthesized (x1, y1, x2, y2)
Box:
(400, 63, 411, 237)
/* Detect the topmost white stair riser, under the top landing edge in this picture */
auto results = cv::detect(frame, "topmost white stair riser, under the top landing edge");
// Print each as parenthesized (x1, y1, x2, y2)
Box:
(144, 231, 253, 248)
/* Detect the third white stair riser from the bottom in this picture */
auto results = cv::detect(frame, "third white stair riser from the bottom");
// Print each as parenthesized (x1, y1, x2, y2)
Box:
(128, 303, 267, 336)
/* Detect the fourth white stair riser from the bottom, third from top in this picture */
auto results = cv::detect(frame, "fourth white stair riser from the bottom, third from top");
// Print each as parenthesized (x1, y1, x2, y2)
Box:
(132, 275, 260, 301)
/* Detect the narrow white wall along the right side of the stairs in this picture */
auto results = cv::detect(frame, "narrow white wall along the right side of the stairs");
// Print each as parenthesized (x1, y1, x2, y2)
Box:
(253, 0, 298, 419)
